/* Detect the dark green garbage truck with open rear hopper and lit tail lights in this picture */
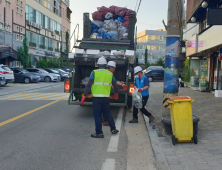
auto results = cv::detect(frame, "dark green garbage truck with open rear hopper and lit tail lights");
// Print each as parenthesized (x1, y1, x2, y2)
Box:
(64, 13, 138, 108)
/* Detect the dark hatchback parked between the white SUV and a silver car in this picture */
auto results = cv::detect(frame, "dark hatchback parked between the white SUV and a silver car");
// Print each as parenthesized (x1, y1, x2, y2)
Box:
(11, 68, 40, 84)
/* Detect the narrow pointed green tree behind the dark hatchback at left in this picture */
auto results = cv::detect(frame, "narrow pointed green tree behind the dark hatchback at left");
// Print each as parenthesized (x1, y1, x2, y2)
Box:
(18, 36, 32, 68)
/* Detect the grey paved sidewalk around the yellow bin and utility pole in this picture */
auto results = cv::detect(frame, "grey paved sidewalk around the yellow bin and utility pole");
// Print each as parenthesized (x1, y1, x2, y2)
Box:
(144, 82, 222, 170)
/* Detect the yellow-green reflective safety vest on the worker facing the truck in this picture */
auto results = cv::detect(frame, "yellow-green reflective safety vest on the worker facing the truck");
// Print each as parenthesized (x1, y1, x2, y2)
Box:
(91, 69, 113, 97)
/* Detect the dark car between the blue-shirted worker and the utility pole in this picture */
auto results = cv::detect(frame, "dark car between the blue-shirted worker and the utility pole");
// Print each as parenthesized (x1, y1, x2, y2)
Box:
(144, 67, 164, 82)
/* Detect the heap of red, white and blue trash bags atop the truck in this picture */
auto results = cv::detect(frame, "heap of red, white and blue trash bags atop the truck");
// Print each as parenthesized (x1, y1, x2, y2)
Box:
(90, 6, 136, 40)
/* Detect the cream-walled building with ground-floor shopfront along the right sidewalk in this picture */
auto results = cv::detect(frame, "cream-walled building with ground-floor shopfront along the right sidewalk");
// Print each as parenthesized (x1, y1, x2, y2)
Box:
(186, 0, 222, 91)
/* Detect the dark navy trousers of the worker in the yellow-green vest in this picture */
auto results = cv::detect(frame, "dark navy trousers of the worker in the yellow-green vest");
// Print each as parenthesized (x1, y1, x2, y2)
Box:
(92, 97, 116, 134)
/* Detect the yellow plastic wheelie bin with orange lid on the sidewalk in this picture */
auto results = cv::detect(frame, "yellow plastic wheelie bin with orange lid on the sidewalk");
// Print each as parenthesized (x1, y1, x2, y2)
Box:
(168, 96, 197, 145)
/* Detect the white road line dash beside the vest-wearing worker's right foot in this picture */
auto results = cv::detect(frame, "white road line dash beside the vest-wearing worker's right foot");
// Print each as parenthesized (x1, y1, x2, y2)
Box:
(107, 107, 123, 152)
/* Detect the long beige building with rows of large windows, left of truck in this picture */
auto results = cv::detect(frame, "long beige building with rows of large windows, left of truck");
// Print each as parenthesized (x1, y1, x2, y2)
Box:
(26, 0, 72, 62)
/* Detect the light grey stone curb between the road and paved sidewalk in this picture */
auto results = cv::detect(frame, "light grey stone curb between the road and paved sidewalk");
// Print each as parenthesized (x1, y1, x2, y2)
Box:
(143, 115, 170, 170)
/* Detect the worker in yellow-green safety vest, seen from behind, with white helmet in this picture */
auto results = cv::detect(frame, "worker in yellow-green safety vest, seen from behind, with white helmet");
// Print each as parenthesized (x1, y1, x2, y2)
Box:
(81, 57, 119, 138)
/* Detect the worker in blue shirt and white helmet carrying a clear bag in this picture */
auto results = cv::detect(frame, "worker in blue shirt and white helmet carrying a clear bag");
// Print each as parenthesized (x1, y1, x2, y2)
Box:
(129, 66, 154, 123)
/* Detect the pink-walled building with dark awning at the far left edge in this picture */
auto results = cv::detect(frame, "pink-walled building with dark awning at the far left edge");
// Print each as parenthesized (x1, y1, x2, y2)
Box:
(0, 0, 26, 65)
